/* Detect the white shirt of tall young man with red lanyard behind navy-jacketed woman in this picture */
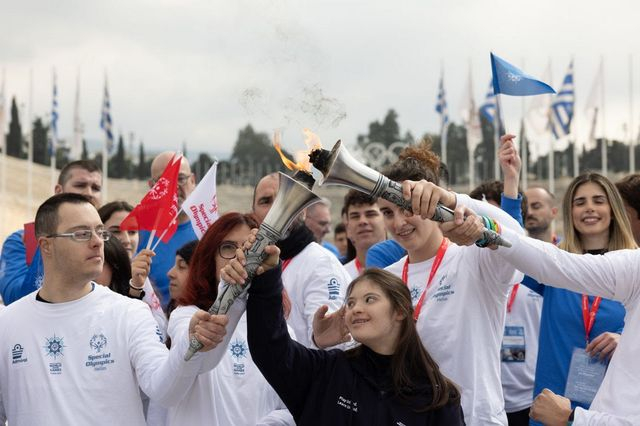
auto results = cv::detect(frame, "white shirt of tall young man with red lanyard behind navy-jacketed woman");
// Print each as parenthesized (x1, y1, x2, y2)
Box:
(386, 194, 523, 426)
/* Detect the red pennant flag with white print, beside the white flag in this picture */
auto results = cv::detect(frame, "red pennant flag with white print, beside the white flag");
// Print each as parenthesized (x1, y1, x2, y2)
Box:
(120, 155, 182, 243)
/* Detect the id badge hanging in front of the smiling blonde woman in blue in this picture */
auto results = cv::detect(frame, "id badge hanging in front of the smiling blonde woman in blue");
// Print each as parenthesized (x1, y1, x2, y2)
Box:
(564, 348, 607, 405)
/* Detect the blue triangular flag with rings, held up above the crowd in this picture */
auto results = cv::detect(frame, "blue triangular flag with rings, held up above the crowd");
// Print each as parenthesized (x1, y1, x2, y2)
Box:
(491, 53, 556, 96)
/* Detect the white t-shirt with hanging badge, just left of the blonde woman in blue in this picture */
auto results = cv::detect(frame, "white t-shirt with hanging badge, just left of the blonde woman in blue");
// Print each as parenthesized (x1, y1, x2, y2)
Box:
(502, 284, 542, 413)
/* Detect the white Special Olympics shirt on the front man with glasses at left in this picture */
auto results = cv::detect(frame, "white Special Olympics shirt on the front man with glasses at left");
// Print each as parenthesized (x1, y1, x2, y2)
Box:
(0, 284, 216, 426)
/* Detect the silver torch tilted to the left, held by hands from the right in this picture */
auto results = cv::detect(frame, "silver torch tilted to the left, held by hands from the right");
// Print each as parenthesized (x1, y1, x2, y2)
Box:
(309, 141, 511, 247)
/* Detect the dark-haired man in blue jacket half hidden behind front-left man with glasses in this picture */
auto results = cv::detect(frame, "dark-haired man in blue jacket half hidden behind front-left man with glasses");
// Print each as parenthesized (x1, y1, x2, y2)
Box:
(0, 160, 102, 305)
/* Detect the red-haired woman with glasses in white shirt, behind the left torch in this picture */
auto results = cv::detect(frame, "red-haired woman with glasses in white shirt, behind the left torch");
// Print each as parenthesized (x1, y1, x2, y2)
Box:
(167, 212, 295, 425)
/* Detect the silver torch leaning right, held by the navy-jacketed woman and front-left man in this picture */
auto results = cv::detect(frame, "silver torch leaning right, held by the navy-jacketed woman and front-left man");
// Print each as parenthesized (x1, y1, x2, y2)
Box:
(184, 170, 320, 361)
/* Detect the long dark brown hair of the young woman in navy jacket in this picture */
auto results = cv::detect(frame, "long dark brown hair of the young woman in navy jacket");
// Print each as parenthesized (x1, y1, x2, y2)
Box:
(345, 268, 460, 411)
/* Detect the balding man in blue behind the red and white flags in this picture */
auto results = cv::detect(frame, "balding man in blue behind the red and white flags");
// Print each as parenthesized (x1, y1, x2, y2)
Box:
(138, 151, 198, 310)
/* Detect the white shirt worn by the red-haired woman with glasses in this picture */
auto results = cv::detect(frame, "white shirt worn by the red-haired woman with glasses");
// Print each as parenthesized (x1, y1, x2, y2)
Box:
(167, 306, 295, 426)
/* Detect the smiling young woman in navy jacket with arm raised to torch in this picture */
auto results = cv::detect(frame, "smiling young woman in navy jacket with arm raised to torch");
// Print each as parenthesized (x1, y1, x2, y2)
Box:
(223, 241, 464, 425)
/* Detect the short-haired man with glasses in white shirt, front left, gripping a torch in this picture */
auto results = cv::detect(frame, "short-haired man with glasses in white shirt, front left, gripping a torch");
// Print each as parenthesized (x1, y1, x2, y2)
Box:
(0, 194, 229, 426)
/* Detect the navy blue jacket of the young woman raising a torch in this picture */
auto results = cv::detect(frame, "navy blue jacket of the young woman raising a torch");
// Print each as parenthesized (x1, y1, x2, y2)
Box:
(247, 268, 464, 426)
